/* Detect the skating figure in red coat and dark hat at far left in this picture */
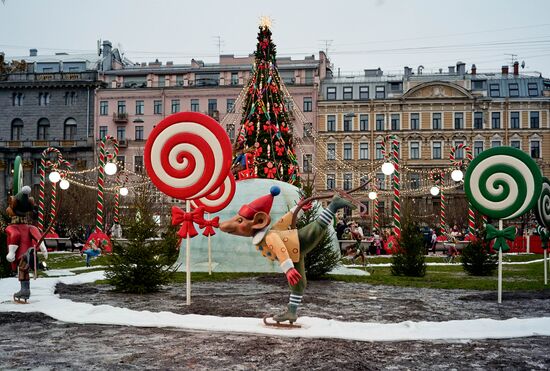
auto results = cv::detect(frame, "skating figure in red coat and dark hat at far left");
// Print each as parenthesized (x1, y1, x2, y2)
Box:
(6, 186, 48, 301)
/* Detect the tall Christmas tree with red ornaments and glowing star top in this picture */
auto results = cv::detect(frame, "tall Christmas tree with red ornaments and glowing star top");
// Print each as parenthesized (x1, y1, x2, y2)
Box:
(234, 22, 300, 185)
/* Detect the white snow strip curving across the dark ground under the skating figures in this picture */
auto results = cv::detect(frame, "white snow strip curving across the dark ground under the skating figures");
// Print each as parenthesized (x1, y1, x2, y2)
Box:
(0, 271, 550, 341)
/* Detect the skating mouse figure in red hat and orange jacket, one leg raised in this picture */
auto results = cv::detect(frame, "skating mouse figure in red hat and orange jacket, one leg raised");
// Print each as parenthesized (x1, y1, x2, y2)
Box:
(220, 186, 355, 324)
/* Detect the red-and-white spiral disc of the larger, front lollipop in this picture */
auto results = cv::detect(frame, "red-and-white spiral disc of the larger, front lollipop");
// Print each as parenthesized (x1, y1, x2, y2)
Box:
(145, 112, 232, 200)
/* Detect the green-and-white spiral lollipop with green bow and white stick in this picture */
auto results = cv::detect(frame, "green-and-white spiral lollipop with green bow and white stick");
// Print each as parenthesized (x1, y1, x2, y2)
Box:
(464, 147, 542, 303)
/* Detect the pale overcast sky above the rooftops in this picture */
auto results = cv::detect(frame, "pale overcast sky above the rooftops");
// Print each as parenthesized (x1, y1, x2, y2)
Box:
(0, 0, 550, 77)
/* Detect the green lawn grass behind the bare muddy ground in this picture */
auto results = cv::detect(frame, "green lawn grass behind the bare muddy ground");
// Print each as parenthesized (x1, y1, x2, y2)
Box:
(47, 253, 549, 291)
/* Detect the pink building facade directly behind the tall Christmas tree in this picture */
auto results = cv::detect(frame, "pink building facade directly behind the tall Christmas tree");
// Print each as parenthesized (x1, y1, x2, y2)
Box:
(95, 52, 329, 178)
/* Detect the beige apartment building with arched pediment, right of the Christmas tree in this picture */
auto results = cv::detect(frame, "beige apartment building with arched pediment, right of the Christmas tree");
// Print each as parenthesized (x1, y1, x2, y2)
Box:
(314, 62, 550, 227)
